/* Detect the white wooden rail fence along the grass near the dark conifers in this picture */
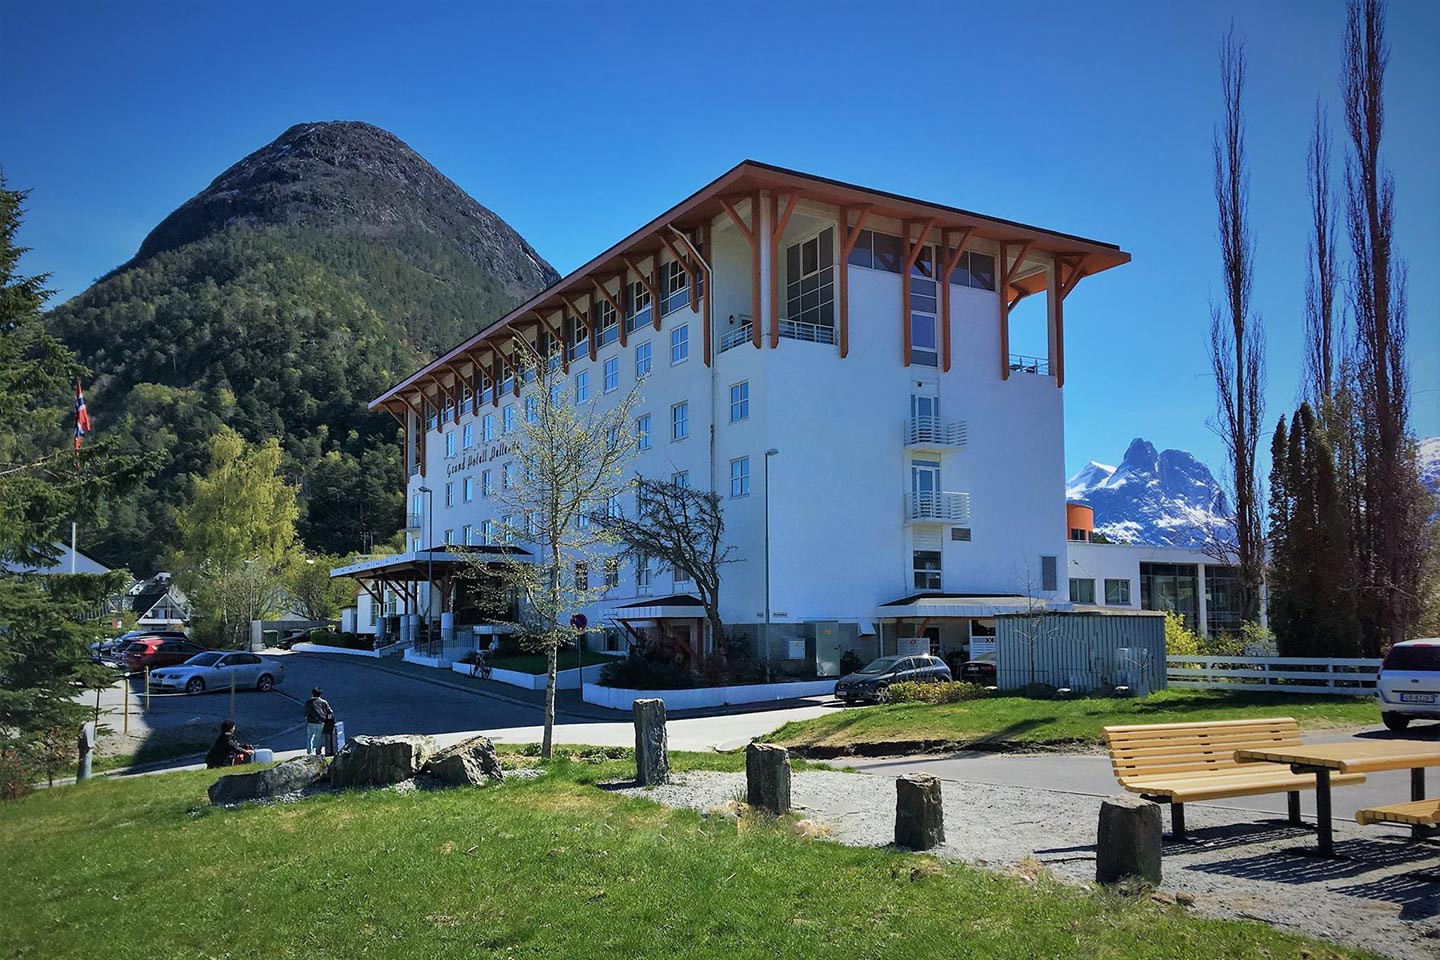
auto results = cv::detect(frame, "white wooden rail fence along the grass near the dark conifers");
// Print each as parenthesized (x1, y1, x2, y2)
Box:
(1165, 655, 1380, 697)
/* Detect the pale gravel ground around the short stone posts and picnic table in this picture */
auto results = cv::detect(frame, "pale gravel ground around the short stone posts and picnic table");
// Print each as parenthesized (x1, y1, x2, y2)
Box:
(622, 771, 1440, 960)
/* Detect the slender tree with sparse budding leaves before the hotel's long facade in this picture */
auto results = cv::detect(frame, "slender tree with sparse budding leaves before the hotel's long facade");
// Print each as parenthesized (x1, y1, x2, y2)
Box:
(477, 337, 638, 757)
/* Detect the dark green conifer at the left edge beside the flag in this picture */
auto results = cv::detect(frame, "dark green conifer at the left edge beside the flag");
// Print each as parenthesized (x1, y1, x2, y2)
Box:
(0, 176, 140, 796)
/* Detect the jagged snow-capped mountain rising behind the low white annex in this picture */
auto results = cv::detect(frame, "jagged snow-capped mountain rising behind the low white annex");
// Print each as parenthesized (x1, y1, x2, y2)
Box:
(1066, 438, 1232, 547)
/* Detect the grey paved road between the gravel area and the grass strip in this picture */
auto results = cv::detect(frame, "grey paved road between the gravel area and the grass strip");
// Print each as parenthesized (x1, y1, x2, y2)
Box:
(837, 724, 1440, 823)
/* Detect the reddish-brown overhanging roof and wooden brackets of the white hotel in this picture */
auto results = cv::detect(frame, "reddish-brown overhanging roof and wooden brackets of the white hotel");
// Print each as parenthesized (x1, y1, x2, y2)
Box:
(370, 160, 1130, 419)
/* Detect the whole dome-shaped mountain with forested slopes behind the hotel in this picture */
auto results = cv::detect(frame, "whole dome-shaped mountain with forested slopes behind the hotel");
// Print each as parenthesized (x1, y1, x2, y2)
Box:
(49, 124, 554, 573)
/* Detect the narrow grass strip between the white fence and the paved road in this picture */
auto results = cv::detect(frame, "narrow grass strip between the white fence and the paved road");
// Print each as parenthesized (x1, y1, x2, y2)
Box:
(766, 689, 1380, 753)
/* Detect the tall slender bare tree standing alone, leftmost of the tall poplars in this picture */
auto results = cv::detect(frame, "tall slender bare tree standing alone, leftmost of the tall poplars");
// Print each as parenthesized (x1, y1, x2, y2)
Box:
(1210, 29, 1266, 620)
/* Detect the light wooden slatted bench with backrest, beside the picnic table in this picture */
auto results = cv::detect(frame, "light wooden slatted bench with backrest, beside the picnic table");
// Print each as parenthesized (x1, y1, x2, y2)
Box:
(1103, 717, 1365, 839)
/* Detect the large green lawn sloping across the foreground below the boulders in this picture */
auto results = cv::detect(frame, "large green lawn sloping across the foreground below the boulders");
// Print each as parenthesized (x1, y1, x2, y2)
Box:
(0, 748, 1369, 960)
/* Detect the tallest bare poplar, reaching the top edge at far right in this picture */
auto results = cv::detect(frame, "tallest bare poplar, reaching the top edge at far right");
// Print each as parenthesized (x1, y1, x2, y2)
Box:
(1341, 0, 1426, 643)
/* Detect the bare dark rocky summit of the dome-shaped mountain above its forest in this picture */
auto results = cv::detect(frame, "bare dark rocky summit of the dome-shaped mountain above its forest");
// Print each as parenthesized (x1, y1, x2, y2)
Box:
(127, 119, 559, 299)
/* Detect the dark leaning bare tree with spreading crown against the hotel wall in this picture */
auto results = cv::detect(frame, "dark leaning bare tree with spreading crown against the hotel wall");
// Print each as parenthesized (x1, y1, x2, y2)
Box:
(599, 476, 733, 649)
